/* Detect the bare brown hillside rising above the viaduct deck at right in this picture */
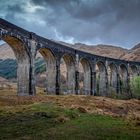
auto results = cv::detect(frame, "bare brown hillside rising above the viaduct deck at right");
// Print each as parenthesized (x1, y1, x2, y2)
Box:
(59, 42, 140, 61)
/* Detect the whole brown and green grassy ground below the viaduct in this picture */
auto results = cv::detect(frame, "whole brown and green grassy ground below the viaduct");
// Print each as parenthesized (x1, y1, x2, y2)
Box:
(0, 90, 140, 140)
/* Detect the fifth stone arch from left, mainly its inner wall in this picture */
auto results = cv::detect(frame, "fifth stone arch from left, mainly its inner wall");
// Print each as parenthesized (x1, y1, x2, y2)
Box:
(96, 61, 107, 96)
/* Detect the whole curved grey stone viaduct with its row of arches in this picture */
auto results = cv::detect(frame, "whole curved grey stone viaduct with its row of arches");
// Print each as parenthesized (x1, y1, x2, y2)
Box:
(0, 19, 140, 96)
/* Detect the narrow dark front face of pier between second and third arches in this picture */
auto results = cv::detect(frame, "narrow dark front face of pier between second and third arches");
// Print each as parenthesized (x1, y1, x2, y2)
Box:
(56, 60, 60, 95)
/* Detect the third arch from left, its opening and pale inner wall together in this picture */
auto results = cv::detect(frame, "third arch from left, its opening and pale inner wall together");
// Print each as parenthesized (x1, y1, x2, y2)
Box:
(60, 54, 75, 94)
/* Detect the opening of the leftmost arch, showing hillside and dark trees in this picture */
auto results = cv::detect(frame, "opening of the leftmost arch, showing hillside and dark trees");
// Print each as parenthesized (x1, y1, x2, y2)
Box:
(0, 41, 17, 95)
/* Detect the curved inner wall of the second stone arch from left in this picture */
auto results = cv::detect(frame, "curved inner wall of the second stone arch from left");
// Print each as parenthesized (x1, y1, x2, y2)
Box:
(38, 48, 56, 94)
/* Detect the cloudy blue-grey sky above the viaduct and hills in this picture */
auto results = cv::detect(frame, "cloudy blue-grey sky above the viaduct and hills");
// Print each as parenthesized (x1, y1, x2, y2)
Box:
(0, 0, 140, 48)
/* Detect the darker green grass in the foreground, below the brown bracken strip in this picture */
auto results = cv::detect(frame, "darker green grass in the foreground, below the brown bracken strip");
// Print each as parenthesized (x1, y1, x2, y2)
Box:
(0, 102, 140, 140)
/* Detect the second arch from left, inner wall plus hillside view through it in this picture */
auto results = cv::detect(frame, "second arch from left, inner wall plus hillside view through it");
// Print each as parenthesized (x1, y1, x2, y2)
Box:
(36, 48, 56, 95)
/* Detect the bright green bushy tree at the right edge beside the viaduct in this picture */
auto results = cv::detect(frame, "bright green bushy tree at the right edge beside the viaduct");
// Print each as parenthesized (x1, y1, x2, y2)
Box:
(130, 76, 140, 99)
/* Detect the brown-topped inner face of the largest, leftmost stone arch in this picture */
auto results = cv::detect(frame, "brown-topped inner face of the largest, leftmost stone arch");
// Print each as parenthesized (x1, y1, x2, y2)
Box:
(1, 34, 31, 95)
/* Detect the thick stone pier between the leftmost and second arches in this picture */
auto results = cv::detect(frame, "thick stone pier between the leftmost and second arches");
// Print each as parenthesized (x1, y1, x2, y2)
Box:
(16, 40, 36, 96)
